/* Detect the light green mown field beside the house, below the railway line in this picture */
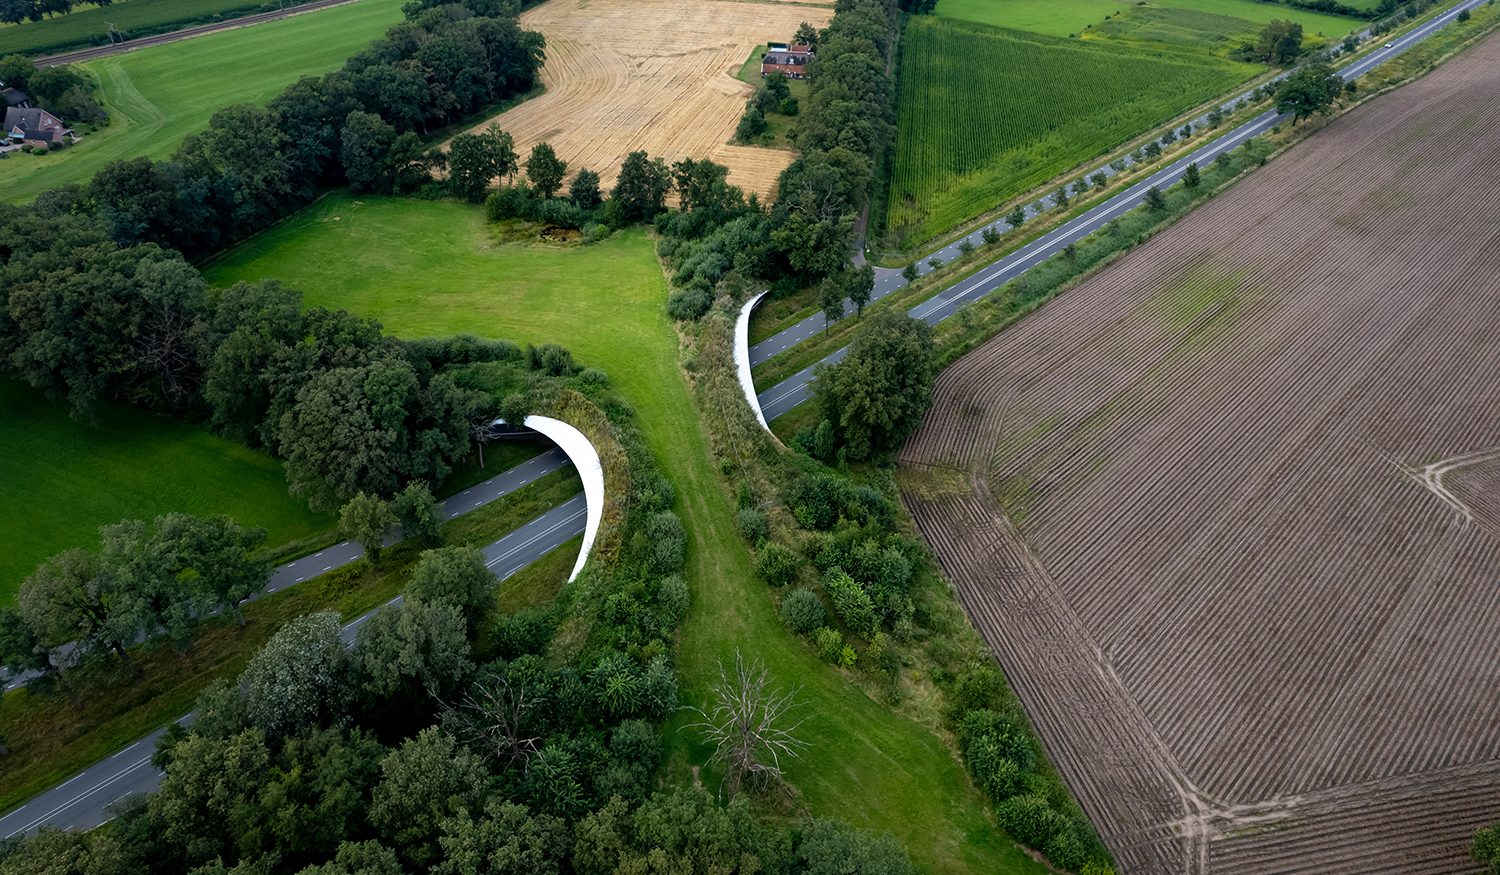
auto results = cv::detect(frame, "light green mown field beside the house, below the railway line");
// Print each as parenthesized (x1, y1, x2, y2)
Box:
(0, 0, 402, 203)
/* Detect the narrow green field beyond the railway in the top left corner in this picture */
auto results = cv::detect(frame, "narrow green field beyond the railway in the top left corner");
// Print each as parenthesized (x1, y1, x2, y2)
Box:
(0, 0, 301, 54)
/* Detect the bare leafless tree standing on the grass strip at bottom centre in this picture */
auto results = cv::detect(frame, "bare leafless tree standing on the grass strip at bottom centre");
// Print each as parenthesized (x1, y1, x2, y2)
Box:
(692, 648, 807, 795)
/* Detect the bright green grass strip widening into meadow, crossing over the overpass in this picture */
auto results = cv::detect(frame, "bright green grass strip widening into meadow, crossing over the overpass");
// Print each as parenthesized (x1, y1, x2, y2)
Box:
(209, 195, 1046, 875)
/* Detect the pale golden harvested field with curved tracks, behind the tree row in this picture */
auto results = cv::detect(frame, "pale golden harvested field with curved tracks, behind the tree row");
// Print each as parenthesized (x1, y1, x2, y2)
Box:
(459, 0, 833, 195)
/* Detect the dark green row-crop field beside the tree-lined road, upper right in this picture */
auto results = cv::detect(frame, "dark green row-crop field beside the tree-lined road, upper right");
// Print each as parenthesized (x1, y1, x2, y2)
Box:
(887, 17, 1260, 250)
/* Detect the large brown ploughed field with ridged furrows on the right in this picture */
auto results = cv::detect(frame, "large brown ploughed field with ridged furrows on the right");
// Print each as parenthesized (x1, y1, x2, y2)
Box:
(902, 27, 1500, 875)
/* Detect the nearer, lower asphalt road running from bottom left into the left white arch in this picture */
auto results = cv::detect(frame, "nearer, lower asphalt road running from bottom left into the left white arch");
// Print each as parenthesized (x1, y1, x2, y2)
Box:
(0, 494, 587, 839)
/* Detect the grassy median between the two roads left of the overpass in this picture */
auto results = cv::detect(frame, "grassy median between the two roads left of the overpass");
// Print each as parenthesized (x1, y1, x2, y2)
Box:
(0, 468, 582, 810)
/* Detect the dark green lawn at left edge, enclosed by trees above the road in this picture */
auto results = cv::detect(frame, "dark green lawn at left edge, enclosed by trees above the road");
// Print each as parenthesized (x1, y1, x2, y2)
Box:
(0, 378, 333, 605)
